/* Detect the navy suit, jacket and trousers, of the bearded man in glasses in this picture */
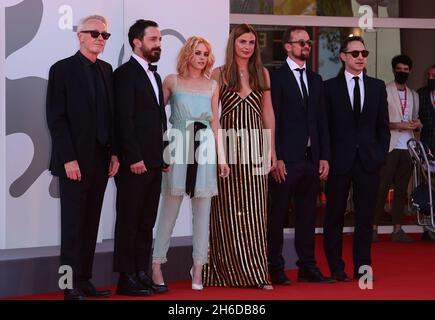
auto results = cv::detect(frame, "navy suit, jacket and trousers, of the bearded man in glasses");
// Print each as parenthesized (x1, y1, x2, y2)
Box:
(268, 63, 329, 270)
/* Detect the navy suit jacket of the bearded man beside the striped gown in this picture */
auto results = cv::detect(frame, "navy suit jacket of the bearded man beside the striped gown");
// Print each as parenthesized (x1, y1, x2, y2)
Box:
(271, 63, 330, 166)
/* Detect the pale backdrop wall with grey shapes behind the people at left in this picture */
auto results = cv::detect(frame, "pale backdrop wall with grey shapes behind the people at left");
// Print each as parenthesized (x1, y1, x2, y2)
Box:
(0, 0, 229, 249)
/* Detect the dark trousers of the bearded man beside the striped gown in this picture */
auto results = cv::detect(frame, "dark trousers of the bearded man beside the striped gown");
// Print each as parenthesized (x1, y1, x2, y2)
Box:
(268, 157, 320, 269)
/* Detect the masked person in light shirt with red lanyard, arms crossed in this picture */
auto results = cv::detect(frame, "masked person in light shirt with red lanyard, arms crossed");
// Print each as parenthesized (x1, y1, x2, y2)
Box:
(372, 55, 422, 243)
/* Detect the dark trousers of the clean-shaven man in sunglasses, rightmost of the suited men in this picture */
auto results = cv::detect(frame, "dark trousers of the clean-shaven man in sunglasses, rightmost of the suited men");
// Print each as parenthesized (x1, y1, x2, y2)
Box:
(323, 158, 379, 272)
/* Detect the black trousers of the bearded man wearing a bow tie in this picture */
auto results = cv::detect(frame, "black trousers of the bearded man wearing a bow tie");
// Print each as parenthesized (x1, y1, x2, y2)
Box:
(114, 166, 162, 273)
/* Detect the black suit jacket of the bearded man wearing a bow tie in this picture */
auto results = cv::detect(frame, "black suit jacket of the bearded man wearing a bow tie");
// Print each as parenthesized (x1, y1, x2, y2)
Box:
(114, 57, 166, 168)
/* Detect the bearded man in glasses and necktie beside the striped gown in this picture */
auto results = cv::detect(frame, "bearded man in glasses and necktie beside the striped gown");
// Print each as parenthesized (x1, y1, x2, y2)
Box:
(268, 27, 333, 285)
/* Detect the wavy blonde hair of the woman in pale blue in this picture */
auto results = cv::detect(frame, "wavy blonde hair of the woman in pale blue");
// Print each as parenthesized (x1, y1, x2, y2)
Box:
(177, 36, 215, 78)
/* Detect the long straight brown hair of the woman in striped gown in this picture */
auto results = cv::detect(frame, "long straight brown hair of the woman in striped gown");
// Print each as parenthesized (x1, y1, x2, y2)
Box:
(222, 23, 269, 92)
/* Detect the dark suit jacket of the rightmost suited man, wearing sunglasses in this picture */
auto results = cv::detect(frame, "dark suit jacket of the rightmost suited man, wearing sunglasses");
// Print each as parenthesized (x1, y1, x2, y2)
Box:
(325, 73, 390, 175)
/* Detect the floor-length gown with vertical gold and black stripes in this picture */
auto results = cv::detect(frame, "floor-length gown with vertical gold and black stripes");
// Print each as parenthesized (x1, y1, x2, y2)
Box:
(203, 85, 270, 287)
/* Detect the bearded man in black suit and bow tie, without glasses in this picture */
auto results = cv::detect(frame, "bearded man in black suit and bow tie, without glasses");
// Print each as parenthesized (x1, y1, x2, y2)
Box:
(114, 19, 168, 296)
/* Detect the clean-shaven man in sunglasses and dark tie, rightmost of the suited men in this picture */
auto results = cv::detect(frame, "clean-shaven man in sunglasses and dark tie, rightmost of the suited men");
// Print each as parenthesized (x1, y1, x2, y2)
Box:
(323, 36, 390, 281)
